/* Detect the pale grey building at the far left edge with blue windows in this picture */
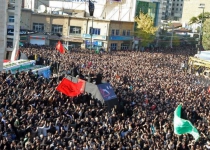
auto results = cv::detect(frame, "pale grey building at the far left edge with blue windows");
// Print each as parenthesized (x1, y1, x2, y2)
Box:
(0, 0, 22, 70)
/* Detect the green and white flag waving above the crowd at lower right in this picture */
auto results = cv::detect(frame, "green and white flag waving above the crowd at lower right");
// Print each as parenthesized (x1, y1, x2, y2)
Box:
(174, 105, 200, 140)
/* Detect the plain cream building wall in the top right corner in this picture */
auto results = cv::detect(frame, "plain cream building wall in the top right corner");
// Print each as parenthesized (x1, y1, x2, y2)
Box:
(182, 0, 210, 24)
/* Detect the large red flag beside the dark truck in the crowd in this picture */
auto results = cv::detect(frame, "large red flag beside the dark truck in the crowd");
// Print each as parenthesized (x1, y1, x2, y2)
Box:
(56, 78, 82, 97)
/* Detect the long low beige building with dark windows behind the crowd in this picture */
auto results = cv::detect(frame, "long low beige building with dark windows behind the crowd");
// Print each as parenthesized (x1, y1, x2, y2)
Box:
(21, 9, 134, 50)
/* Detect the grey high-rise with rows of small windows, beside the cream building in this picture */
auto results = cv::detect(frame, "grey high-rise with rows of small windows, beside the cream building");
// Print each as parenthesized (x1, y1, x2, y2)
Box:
(171, 0, 184, 21)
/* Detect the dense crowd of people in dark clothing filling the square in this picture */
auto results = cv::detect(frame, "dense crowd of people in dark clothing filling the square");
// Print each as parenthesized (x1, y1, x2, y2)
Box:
(0, 47, 210, 150)
